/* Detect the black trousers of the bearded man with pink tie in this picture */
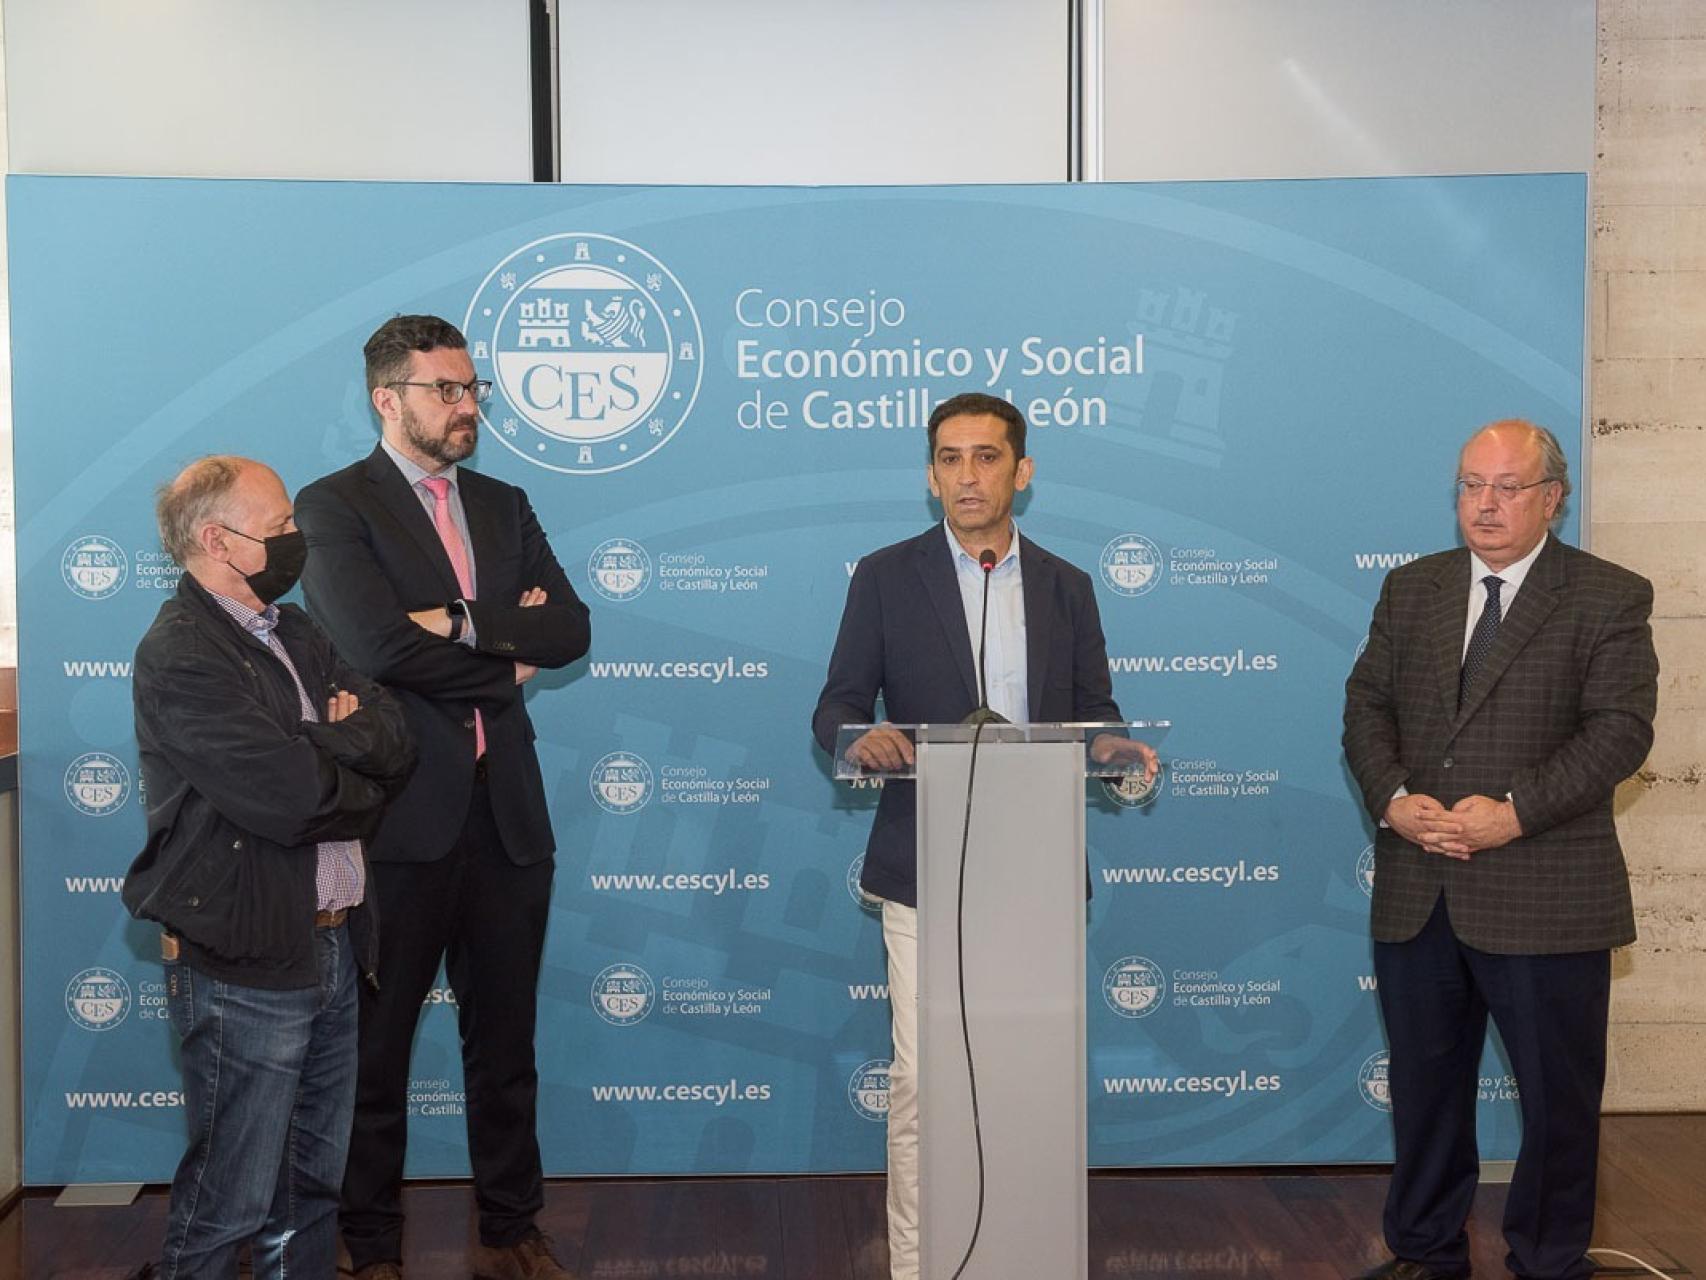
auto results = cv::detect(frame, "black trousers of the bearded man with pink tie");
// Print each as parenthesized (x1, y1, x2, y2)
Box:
(338, 780, 553, 1268)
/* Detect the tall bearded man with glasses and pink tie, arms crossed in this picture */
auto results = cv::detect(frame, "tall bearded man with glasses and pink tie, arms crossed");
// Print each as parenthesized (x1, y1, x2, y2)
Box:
(297, 316, 590, 1280)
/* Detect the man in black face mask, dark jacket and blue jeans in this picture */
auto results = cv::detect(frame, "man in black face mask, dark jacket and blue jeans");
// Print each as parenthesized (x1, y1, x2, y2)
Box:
(125, 457, 415, 1277)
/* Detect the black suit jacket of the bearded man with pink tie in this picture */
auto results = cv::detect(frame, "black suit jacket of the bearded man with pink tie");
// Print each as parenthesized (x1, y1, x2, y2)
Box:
(297, 449, 592, 865)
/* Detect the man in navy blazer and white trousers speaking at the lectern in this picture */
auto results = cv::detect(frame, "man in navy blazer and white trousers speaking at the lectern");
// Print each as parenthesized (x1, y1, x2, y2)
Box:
(812, 393, 1153, 1280)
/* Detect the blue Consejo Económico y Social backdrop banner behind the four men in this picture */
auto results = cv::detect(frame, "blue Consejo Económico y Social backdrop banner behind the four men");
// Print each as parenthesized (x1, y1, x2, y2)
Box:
(7, 174, 1587, 1184)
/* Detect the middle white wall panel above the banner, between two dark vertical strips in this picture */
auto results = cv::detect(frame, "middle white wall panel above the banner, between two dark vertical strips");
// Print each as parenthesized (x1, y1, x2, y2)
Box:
(560, 0, 1066, 183)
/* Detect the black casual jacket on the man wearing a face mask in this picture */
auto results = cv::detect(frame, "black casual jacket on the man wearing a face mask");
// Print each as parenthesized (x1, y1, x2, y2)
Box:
(123, 573, 415, 988)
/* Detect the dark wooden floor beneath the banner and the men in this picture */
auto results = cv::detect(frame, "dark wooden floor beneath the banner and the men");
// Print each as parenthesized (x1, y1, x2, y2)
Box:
(0, 1116, 1706, 1280)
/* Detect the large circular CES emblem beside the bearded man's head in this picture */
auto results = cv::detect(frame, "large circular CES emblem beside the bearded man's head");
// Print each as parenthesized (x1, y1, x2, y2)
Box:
(462, 232, 705, 476)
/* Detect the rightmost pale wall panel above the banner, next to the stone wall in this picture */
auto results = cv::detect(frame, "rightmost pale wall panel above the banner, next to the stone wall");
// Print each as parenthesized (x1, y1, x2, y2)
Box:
(1102, 0, 1595, 181)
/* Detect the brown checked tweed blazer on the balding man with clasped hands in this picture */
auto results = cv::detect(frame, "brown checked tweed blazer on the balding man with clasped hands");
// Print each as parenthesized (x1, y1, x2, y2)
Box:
(1344, 534, 1658, 954)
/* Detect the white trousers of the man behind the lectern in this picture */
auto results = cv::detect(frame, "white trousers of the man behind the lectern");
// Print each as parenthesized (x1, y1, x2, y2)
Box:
(882, 901, 918, 1280)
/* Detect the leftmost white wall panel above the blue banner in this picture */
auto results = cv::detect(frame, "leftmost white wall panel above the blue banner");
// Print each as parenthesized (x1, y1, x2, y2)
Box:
(5, 0, 532, 181)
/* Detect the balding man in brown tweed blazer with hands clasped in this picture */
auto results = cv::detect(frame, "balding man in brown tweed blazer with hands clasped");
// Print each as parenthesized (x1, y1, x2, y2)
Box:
(1344, 422, 1658, 1280)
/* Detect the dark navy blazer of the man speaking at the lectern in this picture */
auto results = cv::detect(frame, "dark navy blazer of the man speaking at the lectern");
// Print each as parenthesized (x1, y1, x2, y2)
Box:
(812, 524, 1123, 906)
